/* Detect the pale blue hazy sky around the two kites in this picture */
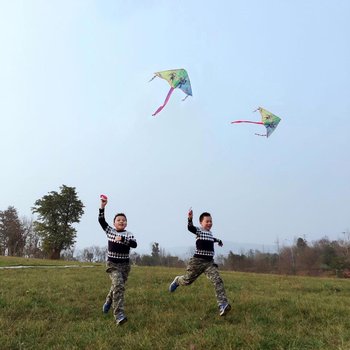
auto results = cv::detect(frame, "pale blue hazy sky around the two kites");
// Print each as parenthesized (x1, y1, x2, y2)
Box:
(0, 0, 350, 251)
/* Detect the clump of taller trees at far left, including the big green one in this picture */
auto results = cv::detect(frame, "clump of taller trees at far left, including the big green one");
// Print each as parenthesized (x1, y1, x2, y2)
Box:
(0, 185, 84, 259)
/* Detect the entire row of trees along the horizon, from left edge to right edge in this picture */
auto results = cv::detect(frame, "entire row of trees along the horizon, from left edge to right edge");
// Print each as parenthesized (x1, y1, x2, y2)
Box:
(0, 185, 350, 277)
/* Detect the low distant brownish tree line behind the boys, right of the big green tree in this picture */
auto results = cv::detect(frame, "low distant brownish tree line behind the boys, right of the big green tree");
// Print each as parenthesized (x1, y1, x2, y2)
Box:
(77, 237, 350, 278)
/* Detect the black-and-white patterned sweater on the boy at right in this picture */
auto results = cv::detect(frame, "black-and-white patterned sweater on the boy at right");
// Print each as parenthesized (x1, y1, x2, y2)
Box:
(187, 218, 220, 260)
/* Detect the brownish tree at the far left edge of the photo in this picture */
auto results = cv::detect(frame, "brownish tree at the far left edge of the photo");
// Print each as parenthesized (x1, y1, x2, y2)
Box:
(0, 206, 25, 256)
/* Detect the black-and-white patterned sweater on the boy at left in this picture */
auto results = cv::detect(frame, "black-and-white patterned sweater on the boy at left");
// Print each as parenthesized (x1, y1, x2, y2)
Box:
(98, 208, 137, 264)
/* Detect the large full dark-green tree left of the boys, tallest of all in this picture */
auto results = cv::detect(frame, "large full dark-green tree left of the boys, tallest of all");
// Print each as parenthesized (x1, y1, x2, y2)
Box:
(32, 185, 84, 259)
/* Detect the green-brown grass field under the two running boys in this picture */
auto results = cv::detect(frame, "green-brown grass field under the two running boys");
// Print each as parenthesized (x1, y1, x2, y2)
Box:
(0, 257, 350, 350)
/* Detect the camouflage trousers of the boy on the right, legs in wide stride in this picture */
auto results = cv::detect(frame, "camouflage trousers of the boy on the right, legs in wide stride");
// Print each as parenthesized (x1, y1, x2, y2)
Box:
(175, 257, 227, 306)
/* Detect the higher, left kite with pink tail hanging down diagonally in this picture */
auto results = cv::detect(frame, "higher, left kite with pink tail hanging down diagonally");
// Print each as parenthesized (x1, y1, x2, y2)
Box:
(150, 69, 192, 116)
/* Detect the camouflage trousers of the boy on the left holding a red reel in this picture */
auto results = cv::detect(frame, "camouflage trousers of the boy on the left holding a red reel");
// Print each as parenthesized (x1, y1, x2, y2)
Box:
(106, 261, 130, 319)
